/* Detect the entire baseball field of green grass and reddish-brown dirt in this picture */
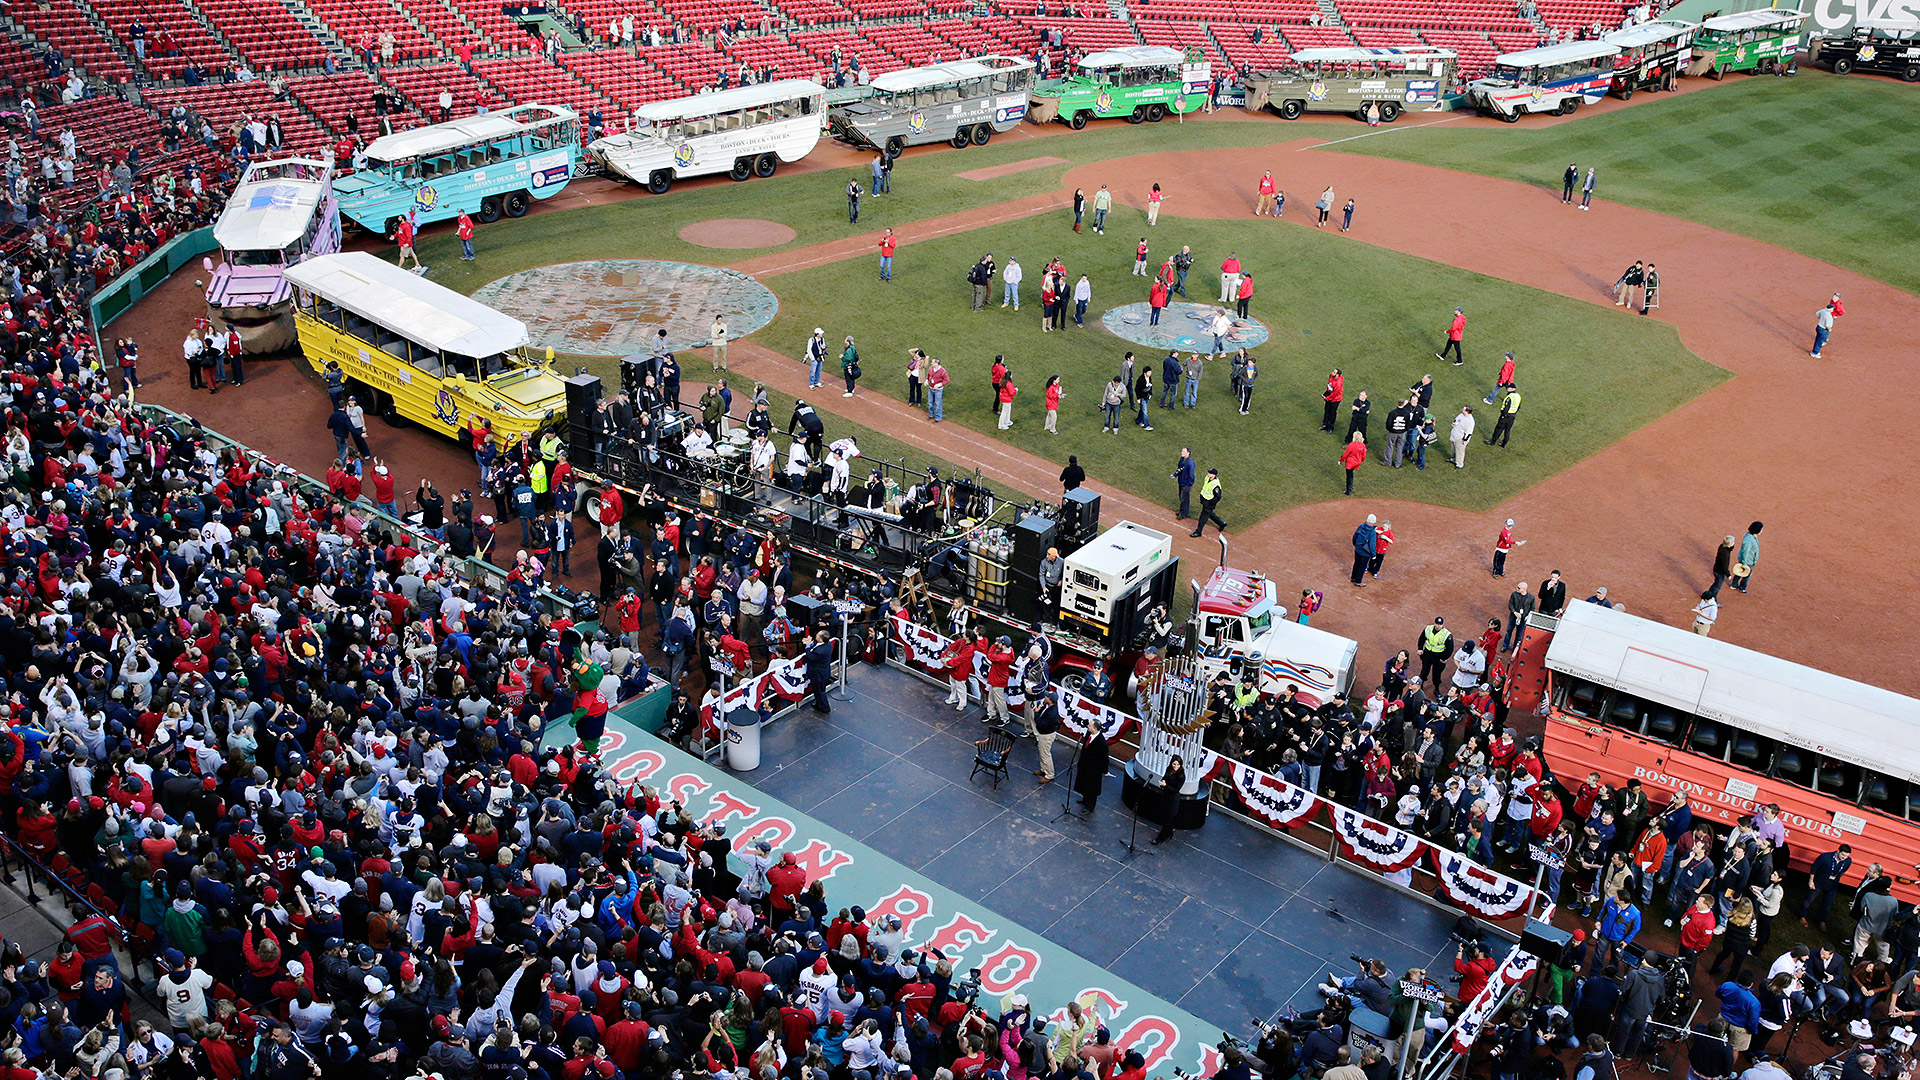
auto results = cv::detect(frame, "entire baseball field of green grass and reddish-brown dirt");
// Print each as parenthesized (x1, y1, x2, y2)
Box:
(288, 71, 1920, 690)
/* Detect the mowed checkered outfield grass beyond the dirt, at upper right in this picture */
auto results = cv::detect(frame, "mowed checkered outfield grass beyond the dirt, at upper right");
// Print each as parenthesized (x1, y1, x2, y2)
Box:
(1336, 69, 1920, 292)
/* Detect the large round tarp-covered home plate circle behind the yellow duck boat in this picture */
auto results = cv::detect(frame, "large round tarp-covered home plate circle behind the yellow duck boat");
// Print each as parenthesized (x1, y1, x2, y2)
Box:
(474, 259, 780, 356)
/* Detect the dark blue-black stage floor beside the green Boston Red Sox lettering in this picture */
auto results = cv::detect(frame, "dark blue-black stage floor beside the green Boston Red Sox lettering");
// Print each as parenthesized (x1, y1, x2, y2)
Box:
(725, 665, 1459, 1032)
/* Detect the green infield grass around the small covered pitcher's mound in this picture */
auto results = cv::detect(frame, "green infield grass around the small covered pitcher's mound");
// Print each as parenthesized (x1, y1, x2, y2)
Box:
(756, 209, 1724, 523)
